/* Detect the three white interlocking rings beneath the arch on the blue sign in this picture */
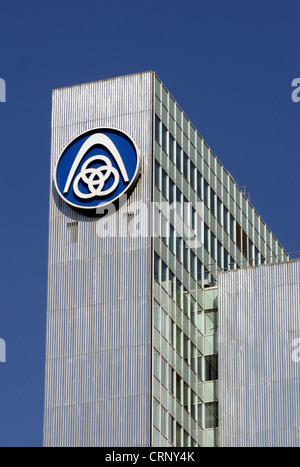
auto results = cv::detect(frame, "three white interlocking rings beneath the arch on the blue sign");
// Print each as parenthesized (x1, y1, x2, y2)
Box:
(73, 156, 120, 199)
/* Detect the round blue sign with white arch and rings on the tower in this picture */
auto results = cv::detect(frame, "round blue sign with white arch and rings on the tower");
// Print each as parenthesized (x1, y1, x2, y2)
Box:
(54, 128, 139, 210)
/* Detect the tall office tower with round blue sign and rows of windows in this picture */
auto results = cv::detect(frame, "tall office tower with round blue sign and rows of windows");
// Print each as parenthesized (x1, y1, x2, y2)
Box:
(44, 72, 288, 446)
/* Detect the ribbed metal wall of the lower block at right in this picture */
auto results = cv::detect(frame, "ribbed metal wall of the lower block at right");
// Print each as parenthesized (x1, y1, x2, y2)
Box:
(218, 261, 300, 447)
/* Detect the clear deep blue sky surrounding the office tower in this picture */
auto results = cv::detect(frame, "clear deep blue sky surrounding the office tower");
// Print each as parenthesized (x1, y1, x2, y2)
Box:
(0, 0, 300, 446)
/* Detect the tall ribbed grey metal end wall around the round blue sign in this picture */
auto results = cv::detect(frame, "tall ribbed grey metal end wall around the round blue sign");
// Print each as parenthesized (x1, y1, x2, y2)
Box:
(44, 72, 153, 446)
